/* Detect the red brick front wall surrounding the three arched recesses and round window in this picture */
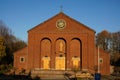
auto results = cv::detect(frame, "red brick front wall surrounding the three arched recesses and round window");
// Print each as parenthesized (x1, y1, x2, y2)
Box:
(28, 14, 95, 69)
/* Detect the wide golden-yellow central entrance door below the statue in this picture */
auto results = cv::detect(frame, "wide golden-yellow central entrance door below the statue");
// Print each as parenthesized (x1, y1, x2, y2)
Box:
(55, 57, 65, 70)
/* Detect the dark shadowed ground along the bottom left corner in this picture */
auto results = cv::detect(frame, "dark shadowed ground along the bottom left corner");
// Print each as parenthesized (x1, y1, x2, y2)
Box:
(0, 74, 41, 80)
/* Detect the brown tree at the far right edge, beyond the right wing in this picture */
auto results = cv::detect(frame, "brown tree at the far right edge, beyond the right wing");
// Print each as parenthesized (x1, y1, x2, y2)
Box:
(110, 31, 120, 66)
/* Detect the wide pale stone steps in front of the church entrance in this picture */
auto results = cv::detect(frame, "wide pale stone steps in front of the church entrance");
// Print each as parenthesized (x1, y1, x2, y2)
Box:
(32, 70, 93, 80)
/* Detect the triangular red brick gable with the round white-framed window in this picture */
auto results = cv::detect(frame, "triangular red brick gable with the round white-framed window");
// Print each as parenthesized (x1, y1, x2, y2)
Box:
(28, 12, 95, 33)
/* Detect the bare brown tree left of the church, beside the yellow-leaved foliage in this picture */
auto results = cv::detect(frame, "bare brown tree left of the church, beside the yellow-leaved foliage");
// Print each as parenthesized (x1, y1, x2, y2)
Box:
(0, 20, 26, 64)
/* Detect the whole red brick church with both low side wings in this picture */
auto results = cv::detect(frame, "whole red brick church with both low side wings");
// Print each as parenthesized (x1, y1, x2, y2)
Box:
(14, 12, 110, 75)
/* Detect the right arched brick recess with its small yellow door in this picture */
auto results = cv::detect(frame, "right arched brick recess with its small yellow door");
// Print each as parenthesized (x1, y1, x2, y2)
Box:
(70, 38, 82, 69)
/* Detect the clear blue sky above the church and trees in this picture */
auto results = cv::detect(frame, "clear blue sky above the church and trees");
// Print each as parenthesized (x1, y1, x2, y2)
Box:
(0, 0, 120, 41)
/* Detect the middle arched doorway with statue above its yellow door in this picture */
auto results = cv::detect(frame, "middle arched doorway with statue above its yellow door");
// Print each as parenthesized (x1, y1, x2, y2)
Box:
(55, 38, 66, 70)
